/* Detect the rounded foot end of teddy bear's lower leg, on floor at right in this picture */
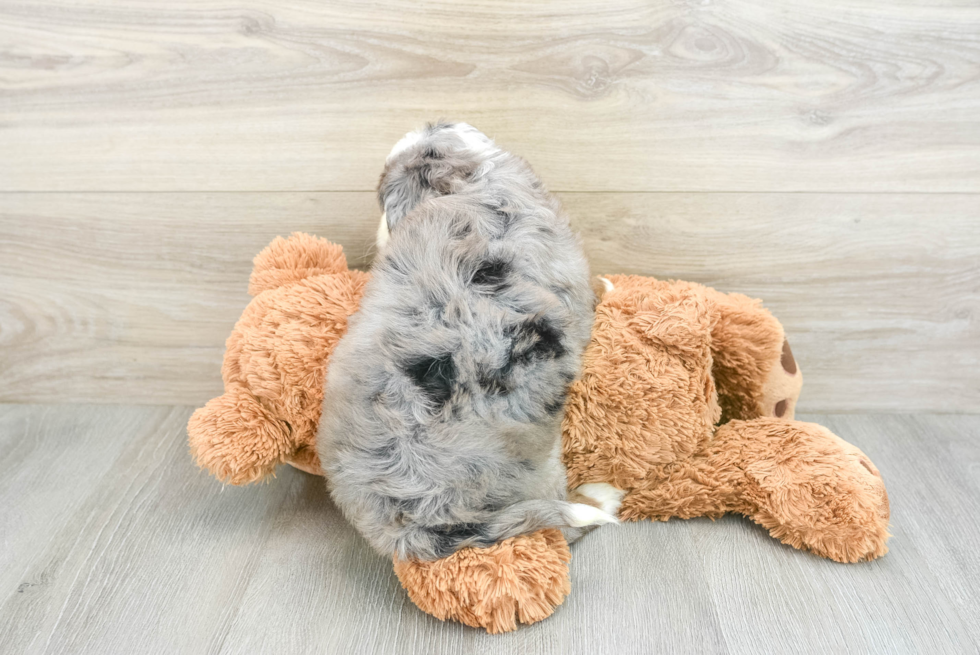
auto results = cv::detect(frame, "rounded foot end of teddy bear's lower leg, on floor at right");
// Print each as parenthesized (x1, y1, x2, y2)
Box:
(708, 418, 889, 562)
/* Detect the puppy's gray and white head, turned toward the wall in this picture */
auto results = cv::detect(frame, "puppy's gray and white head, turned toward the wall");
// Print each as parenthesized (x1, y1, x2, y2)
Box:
(377, 123, 499, 248)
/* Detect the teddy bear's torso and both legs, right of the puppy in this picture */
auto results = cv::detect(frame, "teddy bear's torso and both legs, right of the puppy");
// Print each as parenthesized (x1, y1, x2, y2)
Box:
(564, 275, 889, 562)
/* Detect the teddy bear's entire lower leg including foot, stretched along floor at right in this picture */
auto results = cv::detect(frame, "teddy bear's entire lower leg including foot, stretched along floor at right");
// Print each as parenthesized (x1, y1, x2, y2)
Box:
(620, 417, 889, 562)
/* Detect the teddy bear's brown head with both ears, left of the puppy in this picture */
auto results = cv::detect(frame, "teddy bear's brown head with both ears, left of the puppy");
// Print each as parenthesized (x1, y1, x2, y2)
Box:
(187, 234, 370, 484)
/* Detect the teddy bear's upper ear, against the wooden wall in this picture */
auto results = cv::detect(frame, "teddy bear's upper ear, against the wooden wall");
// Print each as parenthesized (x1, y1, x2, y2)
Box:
(248, 232, 347, 296)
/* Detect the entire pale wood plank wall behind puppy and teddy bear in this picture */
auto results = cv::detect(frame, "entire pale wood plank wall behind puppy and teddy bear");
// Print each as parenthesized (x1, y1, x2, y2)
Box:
(0, 0, 980, 412)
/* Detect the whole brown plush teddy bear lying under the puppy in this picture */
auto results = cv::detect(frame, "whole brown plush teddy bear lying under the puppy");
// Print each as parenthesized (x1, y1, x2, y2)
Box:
(188, 234, 889, 632)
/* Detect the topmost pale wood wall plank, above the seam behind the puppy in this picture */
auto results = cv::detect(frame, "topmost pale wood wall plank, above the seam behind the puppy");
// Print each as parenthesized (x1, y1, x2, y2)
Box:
(0, 0, 980, 192)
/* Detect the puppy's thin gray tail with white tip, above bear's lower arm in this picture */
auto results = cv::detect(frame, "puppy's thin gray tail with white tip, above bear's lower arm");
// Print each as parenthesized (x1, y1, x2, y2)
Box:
(398, 500, 618, 559)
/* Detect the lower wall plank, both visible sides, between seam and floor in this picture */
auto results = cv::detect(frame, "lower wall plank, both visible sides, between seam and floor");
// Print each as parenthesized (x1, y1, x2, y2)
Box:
(0, 193, 980, 412)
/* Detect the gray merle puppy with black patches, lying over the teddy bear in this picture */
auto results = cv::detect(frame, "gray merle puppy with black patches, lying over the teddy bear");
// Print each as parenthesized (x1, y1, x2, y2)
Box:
(318, 124, 619, 559)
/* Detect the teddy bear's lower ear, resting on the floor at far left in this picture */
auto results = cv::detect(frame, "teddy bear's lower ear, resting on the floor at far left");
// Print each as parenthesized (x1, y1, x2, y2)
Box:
(187, 385, 293, 485)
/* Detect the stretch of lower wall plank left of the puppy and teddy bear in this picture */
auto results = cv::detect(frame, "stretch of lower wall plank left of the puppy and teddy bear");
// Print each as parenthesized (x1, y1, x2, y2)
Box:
(0, 193, 378, 404)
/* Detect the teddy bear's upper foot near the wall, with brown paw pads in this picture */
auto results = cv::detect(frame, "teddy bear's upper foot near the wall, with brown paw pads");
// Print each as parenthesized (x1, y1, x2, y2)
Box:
(707, 288, 803, 422)
